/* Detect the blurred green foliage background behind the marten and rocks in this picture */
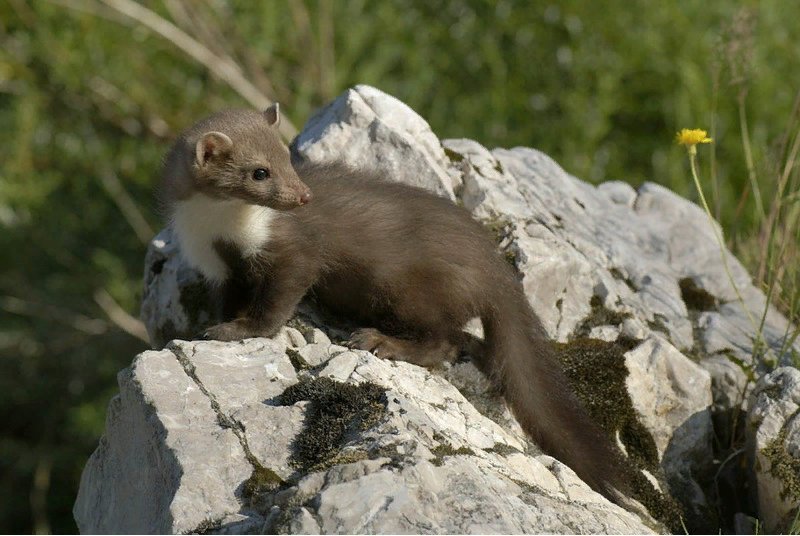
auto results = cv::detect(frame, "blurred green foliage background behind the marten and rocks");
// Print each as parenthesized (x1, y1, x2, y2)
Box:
(0, 0, 800, 533)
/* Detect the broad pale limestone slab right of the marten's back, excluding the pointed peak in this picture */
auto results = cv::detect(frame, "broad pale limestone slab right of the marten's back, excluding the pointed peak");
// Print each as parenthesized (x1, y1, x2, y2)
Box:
(442, 140, 800, 372)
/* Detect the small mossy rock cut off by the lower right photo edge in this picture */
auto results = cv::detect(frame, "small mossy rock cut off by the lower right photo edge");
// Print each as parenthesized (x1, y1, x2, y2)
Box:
(747, 367, 800, 534)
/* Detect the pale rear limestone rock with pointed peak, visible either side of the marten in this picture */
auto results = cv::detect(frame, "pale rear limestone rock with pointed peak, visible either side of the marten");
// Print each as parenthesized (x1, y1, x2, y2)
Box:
(142, 86, 800, 374)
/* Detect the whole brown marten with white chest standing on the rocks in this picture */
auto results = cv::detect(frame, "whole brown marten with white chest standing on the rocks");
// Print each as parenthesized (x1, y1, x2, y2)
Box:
(161, 105, 628, 502)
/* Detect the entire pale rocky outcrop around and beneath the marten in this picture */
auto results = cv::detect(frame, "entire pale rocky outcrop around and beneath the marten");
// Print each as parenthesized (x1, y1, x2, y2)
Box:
(75, 86, 791, 532)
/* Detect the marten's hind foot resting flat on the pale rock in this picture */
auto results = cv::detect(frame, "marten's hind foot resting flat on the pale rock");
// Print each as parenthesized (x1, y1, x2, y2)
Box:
(350, 328, 460, 367)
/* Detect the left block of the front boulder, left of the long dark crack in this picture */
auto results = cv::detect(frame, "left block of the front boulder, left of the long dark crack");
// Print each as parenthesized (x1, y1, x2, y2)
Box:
(74, 349, 252, 534)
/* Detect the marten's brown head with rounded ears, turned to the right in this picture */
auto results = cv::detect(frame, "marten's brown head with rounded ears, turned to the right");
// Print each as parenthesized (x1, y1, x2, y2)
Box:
(176, 104, 311, 210)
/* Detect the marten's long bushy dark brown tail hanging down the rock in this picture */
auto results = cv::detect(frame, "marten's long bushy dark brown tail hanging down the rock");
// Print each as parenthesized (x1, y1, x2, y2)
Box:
(482, 287, 628, 503)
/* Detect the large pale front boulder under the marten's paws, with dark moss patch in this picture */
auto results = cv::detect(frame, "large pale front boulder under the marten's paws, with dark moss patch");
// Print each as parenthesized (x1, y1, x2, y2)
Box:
(75, 339, 651, 533)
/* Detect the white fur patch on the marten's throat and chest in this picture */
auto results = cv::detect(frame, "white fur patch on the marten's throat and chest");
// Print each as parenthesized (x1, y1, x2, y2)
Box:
(172, 194, 275, 283)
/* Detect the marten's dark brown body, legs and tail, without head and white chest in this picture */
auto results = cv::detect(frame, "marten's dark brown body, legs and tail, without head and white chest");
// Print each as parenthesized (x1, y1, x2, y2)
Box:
(159, 108, 626, 500)
